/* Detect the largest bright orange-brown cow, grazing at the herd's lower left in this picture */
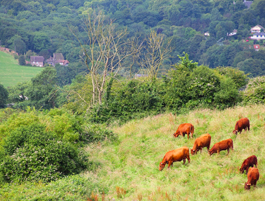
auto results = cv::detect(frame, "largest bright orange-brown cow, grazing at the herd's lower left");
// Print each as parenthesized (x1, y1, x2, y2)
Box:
(159, 147, 190, 171)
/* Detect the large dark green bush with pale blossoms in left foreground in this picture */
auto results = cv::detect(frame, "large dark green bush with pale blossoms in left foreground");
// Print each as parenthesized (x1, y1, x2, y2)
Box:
(0, 123, 86, 182)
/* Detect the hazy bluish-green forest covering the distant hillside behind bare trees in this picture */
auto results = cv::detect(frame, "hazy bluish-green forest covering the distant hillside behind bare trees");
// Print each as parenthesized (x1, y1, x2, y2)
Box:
(0, 0, 265, 78)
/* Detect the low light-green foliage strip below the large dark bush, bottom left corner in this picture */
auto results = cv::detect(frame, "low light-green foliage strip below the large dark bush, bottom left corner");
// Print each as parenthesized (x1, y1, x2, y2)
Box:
(0, 174, 109, 201)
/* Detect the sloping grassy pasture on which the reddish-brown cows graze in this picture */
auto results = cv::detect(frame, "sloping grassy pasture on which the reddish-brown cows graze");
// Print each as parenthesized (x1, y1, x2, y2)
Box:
(0, 105, 265, 201)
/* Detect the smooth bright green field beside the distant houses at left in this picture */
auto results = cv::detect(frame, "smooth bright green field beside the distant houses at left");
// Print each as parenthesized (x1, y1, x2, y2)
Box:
(0, 51, 43, 87)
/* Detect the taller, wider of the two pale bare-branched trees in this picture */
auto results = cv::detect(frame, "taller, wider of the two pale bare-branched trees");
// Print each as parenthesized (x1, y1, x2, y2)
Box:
(72, 12, 138, 104)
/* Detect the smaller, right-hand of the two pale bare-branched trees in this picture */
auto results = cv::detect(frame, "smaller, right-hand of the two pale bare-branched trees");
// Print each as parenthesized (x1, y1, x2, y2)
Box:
(140, 31, 171, 79)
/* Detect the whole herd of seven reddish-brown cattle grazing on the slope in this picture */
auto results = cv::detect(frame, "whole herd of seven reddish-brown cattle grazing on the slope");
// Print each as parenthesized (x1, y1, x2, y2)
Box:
(159, 118, 259, 189)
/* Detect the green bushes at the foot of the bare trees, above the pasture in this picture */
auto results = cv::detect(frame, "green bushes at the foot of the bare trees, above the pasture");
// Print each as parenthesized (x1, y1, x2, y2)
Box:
(86, 80, 163, 123)
